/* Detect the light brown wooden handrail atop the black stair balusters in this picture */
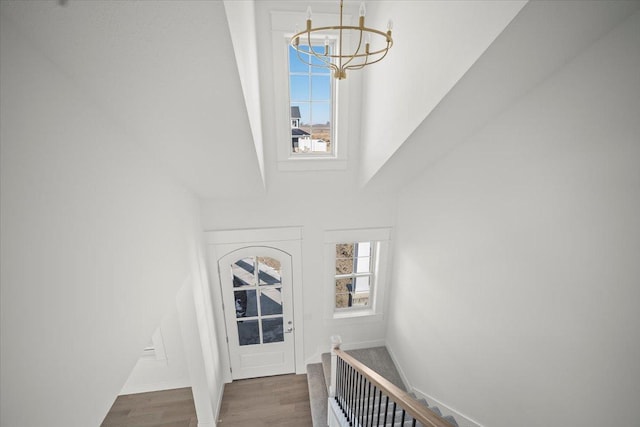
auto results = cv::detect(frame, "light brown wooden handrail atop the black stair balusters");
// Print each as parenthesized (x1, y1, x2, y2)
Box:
(333, 349, 452, 427)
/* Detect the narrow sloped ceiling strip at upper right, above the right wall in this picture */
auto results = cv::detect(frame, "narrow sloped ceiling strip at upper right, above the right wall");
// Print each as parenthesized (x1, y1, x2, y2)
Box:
(361, 1, 640, 191)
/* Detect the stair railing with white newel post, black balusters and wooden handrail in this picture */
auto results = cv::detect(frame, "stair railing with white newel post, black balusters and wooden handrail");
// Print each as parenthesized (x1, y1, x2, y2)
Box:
(329, 337, 452, 427)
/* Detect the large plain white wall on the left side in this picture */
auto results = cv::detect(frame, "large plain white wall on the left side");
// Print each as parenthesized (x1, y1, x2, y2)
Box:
(0, 16, 209, 427)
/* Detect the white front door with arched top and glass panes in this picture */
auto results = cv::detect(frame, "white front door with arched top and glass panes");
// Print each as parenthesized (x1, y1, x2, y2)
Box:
(218, 246, 295, 379)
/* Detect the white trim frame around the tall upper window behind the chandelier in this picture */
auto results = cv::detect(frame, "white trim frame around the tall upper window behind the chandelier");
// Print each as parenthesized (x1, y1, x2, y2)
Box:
(271, 11, 352, 171)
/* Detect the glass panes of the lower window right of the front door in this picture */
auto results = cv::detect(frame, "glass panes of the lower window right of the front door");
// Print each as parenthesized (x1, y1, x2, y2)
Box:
(334, 241, 376, 310)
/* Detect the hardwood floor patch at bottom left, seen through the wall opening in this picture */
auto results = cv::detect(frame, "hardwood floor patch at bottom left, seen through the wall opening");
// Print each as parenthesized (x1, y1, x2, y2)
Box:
(101, 387, 198, 427)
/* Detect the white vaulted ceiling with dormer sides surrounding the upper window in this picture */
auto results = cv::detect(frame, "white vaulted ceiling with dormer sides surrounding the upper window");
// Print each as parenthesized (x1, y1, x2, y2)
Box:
(2, 0, 637, 198)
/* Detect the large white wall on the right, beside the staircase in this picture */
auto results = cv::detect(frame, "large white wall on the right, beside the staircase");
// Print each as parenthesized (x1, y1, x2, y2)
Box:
(388, 13, 640, 427)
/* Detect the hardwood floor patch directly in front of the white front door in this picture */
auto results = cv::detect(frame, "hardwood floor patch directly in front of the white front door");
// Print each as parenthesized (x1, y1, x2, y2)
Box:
(218, 374, 312, 427)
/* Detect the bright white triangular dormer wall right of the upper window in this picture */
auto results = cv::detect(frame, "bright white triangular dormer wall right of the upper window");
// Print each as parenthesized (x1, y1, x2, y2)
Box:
(359, 0, 526, 184)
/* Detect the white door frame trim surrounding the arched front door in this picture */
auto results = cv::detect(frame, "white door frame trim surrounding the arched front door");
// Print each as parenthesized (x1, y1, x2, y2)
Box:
(205, 227, 306, 383)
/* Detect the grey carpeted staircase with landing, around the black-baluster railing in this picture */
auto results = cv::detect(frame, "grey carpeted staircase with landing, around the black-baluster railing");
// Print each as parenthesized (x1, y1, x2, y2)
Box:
(307, 347, 458, 427)
